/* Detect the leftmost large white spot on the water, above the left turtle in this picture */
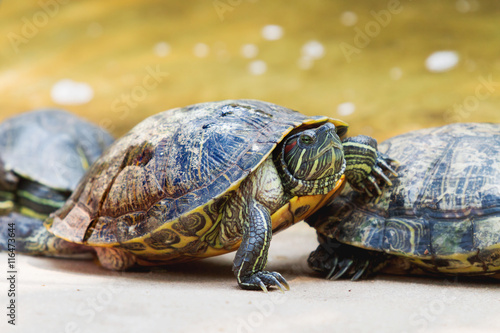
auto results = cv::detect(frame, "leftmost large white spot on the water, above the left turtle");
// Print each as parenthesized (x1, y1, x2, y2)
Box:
(50, 79, 94, 105)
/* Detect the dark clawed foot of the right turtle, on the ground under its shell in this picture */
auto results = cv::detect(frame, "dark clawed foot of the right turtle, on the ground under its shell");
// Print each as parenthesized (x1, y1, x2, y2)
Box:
(307, 241, 386, 281)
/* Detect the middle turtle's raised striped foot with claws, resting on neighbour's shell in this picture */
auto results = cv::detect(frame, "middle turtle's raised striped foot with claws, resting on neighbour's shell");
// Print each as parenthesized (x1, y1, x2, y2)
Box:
(342, 135, 397, 197)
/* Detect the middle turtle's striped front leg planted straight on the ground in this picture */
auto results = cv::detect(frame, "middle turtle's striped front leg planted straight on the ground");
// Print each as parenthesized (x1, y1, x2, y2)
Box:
(233, 201, 290, 292)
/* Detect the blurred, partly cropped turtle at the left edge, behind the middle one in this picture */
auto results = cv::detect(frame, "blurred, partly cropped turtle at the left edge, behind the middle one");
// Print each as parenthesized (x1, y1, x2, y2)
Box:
(0, 108, 114, 256)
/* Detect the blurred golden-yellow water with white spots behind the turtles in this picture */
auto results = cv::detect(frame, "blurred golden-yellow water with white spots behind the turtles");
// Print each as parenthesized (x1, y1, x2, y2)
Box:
(0, 0, 500, 140)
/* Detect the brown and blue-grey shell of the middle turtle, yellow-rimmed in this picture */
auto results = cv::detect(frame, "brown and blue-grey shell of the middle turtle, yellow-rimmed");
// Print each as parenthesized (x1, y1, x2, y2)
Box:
(47, 100, 347, 255)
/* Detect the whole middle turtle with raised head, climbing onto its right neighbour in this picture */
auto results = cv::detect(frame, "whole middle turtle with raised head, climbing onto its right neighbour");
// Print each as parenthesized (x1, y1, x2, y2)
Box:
(41, 100, 394, 291)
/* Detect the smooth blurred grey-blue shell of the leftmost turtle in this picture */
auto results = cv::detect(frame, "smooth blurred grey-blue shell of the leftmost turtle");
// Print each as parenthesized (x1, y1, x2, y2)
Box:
(0, 109, 113, 191)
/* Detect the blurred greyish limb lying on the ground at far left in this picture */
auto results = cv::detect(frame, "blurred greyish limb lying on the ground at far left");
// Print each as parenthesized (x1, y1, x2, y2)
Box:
(0, 213, 93, 258)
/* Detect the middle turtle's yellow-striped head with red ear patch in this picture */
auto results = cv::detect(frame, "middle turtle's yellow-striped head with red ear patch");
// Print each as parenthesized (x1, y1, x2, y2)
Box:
(281, 123, 345, 195)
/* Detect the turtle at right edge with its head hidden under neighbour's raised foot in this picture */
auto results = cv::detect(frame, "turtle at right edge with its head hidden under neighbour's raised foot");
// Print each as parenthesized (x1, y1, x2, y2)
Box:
(306, 123, 500, 280)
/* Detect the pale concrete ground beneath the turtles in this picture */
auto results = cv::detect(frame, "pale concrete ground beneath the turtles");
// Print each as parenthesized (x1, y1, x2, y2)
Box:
(0, 224, 500, 333)
